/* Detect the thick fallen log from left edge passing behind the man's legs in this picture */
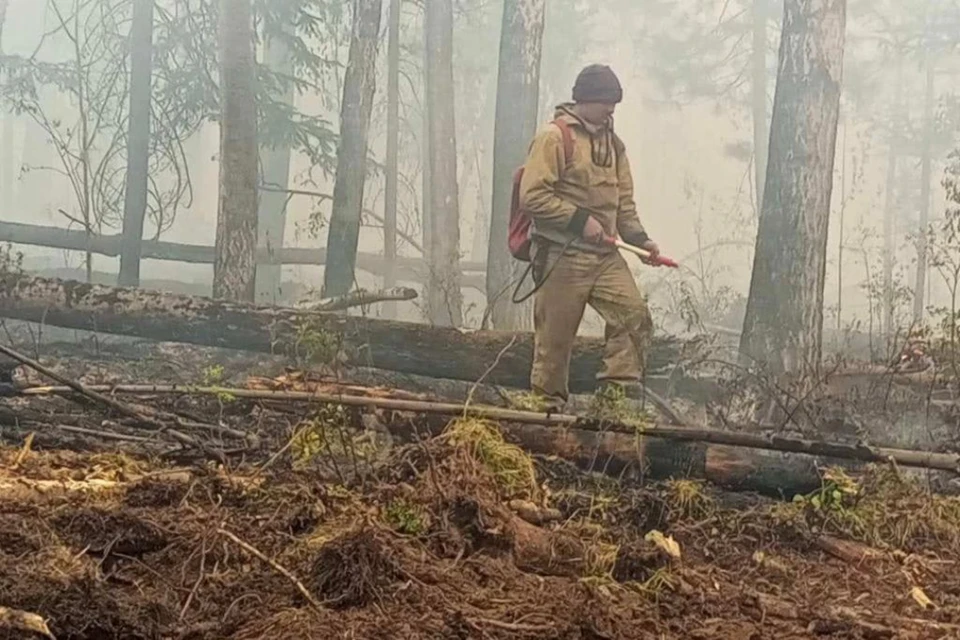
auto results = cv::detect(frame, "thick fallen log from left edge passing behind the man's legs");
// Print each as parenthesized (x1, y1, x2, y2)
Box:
(0, 274, 680, 393)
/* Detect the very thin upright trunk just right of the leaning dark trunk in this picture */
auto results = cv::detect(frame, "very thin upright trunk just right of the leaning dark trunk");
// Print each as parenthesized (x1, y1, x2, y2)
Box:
(383, 0, 403, 318)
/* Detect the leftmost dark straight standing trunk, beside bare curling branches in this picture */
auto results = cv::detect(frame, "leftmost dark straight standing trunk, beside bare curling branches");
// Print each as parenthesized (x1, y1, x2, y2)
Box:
(117, 0, 154, 287)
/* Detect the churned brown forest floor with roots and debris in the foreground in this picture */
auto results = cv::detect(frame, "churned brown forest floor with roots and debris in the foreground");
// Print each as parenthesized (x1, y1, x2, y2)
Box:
(0, 348, 960, 640)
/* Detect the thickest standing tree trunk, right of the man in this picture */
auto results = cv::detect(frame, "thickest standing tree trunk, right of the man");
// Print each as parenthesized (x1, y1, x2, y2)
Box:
(740, 0, 846, 373)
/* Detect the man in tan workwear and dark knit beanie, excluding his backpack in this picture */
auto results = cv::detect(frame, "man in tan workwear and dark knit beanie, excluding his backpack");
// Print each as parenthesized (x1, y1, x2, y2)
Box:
(520, 65, 660, 412)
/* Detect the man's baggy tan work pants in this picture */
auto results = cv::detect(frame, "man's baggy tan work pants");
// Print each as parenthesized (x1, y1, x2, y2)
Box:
(531, 240, 653, 404)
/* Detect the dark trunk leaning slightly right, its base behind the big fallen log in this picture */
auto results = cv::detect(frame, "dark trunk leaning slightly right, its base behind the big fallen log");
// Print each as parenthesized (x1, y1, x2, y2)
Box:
(323, 0, 383, 298)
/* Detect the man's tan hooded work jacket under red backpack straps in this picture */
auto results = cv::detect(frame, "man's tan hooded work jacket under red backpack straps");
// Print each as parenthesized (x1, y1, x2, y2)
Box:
(520, 104, 647, 253)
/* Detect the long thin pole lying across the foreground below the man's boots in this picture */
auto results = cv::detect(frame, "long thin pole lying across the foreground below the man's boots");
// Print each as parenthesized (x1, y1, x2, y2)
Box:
(21, 385, 960, 474)
